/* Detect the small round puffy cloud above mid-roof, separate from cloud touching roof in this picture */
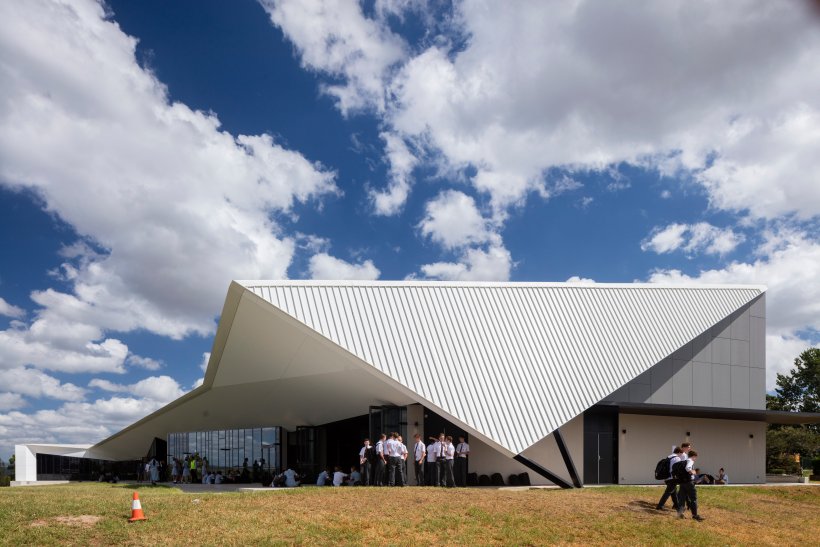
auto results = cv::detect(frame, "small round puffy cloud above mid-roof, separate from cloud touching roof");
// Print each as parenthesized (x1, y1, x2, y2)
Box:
(418, 190, 500, 249)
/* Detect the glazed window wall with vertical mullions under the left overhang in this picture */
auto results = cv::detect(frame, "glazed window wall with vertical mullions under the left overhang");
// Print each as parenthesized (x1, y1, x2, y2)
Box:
(168, 427, 282, 473)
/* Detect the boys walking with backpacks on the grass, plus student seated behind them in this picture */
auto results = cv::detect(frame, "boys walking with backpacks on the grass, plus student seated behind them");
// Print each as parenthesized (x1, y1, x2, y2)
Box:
(656, 442, 729, 521)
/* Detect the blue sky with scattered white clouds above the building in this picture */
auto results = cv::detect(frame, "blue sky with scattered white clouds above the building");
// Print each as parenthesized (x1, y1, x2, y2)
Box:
(0, 0, 820, 460)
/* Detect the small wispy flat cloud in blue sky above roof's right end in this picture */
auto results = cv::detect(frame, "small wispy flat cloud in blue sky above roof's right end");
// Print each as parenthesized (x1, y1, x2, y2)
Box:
(641, 222, 745, 256)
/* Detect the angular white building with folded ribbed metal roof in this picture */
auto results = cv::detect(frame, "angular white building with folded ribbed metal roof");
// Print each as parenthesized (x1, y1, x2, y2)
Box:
(16, 280, 818, 487)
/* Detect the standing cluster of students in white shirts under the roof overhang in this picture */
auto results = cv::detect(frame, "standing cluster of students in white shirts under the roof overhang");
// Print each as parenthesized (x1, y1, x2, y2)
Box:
(359, 432, 470, 488)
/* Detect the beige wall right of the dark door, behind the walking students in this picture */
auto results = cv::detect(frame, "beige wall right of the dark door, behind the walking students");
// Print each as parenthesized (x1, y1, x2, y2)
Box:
(618, 414, 766, 484)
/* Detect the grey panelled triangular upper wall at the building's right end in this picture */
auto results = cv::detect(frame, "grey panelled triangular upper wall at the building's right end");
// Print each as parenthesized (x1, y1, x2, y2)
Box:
(604, 294, 766, 409)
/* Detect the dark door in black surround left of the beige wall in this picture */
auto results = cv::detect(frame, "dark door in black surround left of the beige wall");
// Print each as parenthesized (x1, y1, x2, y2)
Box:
(584, 407, 618, 484)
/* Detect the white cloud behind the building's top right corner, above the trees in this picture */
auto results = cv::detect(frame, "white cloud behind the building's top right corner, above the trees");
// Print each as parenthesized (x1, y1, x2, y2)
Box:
(650, 229, 820, 389)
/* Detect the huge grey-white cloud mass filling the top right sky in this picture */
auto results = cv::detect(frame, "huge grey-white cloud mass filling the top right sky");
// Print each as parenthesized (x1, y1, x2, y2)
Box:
(270, 0, 820, 223)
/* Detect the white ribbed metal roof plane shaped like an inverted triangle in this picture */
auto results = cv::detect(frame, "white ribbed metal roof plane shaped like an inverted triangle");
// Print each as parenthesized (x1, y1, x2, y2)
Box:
(239, 281, 765, 454)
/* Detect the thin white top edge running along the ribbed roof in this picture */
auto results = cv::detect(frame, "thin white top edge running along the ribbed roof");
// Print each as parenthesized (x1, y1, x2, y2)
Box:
(233, 279, 768, 293)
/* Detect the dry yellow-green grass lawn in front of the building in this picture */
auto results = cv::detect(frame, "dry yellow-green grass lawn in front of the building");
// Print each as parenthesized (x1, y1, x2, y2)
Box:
(0, 483, 820, 545)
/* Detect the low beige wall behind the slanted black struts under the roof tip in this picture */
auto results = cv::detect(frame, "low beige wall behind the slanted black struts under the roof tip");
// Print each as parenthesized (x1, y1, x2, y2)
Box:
(468, 415, 584, 485)
